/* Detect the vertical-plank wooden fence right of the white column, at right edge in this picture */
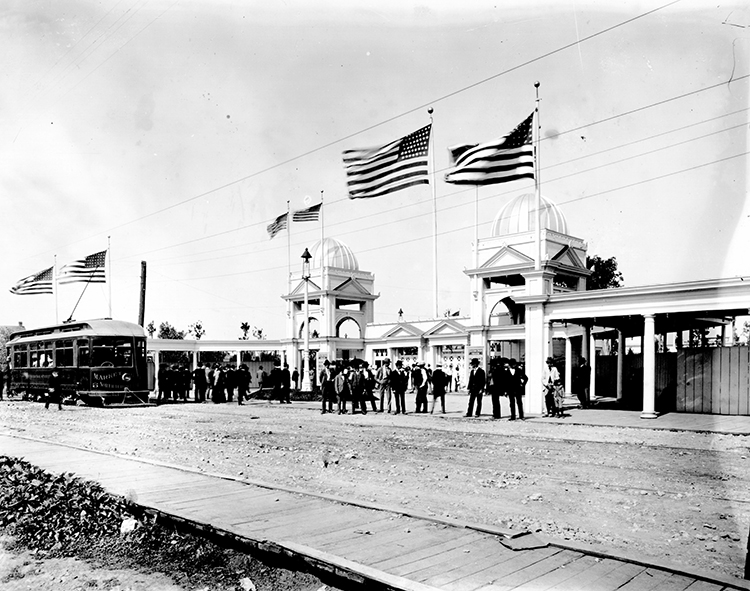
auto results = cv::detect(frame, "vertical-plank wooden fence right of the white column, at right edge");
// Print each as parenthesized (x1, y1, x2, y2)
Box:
(675, 347, 750, 416)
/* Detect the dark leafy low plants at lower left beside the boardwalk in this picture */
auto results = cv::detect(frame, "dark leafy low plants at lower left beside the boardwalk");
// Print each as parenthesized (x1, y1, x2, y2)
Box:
(0, 456, 334, 590)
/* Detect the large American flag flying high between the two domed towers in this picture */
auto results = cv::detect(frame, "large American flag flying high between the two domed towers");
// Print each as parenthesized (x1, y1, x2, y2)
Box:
(344, 125, 432, 199)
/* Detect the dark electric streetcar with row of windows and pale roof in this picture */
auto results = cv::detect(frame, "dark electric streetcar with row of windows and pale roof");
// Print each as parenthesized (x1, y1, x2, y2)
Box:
(6, 319, 153, 406)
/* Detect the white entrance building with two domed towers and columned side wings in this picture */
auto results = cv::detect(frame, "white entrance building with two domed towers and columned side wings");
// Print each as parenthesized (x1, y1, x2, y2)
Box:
(150, 194, 750, 418)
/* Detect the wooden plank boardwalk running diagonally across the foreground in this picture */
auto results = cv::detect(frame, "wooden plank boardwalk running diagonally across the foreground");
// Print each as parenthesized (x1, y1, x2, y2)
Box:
(0, 435, 750, 591)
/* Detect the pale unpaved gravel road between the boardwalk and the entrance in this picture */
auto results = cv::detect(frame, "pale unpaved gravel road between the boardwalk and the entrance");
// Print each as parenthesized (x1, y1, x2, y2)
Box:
(0, 401, 750, 578)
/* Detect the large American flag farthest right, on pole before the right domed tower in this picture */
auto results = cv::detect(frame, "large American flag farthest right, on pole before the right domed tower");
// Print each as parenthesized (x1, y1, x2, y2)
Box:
(445, 113, 534, 185)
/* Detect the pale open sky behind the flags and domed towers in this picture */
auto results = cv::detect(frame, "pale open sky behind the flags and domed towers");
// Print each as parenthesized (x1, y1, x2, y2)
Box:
(0, 0, 750, 339)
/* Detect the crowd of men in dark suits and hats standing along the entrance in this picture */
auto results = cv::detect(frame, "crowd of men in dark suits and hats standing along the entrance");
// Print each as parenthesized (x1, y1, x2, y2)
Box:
(157, 357, 590, 421)
